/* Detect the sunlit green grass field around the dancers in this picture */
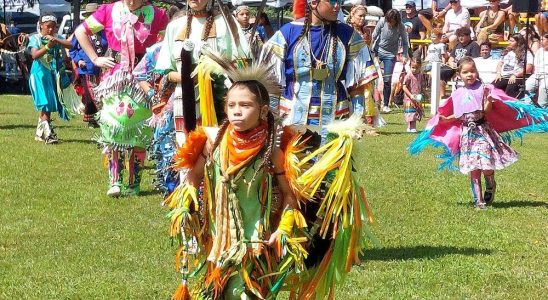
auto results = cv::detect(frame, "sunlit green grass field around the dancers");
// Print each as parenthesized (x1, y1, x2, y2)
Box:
(0, 95, 548, 300)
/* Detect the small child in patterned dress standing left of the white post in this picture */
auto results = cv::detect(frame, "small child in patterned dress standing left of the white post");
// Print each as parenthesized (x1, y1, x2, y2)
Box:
(402, 58, 423, 133)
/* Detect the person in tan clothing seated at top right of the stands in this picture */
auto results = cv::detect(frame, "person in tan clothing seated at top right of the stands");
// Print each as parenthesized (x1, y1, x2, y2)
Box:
(475, 0, 505, 44)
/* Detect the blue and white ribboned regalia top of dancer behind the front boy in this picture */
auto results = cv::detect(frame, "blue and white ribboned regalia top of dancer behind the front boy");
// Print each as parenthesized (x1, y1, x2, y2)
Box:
(264, 19, 376, 136)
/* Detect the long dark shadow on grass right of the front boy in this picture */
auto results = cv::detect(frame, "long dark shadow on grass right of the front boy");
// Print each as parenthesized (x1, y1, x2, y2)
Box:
(361, 245, 493, 261)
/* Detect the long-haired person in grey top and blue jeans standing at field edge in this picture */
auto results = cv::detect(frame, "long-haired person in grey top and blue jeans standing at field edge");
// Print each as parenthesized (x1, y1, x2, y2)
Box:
(373, 9, 409, 112)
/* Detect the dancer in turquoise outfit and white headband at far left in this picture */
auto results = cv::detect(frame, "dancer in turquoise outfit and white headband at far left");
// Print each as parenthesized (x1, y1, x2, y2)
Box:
(28, 15, 77, 144)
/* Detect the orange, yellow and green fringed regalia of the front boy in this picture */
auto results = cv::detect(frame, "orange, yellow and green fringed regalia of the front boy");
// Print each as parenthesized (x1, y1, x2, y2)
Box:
(164, 116, 372, 299)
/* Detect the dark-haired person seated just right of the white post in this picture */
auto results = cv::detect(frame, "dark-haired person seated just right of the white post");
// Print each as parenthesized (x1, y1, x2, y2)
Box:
(440, 27, 480, 96)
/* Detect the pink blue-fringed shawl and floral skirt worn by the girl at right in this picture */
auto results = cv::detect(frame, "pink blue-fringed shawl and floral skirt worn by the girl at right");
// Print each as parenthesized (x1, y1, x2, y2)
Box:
(408, 85, 548, 173)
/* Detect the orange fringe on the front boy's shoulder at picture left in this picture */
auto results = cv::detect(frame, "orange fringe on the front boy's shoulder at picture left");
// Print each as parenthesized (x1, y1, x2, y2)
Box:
(173, 127, 207, 170)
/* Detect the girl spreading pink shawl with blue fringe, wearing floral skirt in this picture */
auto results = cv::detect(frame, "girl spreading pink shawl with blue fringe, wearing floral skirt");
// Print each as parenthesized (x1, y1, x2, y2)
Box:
(409, 57, 548, 209)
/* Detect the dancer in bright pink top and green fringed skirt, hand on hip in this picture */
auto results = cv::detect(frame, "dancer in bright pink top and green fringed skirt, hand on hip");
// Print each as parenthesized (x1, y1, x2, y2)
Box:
(75, 0, 168, 197)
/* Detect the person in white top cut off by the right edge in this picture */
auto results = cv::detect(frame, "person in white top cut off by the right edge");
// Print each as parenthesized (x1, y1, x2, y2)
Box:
(525, 32, 548, 108)
